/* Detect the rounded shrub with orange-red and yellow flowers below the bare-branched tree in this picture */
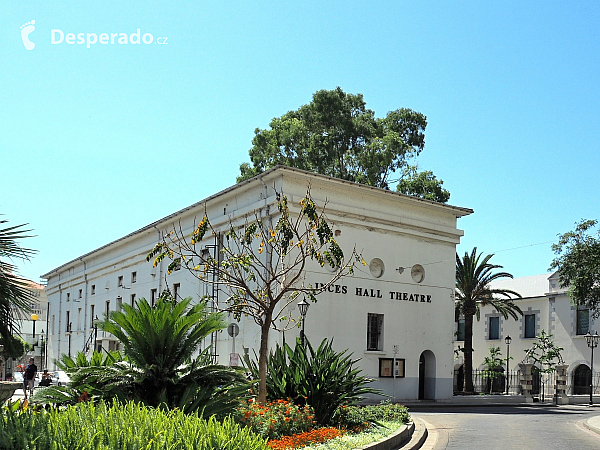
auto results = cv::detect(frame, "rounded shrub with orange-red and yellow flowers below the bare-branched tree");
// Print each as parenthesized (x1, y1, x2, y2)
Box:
(236, 400, 315, 439)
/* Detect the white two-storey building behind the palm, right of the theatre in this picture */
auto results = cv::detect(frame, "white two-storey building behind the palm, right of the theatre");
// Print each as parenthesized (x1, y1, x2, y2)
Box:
(455, 273, 600, 395)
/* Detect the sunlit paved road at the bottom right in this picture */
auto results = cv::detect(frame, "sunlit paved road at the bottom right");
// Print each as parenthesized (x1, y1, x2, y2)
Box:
(411, 406, 600, 450)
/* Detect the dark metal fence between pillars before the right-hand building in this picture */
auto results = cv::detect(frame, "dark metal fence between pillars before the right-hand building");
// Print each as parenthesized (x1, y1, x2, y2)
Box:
(454, 367, 600, 398)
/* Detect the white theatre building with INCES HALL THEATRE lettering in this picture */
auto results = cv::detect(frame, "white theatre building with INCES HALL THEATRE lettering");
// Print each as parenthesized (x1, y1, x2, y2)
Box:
(43, 167, 473, 400)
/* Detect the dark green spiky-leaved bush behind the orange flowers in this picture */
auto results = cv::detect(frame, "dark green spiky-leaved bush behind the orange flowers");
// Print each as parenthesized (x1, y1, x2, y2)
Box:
(245, 339, 381, 426)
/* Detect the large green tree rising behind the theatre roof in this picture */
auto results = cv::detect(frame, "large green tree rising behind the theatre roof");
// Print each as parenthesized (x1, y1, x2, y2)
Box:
(237, 87, 447, 200)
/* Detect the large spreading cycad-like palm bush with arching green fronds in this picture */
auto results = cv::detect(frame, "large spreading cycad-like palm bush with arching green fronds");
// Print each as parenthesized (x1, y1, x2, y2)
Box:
(32, 294, 250, 417)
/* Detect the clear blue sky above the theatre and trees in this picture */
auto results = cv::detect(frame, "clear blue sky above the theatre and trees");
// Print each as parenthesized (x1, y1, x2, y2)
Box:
(0, 0, 600, 280)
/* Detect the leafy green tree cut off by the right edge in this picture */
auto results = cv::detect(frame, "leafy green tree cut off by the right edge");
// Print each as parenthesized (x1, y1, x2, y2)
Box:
(550, 220, 600, 317)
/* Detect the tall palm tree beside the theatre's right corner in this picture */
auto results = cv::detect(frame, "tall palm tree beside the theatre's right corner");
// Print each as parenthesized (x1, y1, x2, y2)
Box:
(456, 247, 523, 393)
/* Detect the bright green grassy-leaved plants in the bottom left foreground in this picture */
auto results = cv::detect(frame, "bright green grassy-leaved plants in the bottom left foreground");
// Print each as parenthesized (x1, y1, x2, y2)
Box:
(0, 401, 267, 450)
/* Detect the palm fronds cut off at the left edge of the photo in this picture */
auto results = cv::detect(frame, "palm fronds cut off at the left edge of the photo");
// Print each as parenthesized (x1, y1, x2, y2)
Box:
(0, 220, 35, 356)
